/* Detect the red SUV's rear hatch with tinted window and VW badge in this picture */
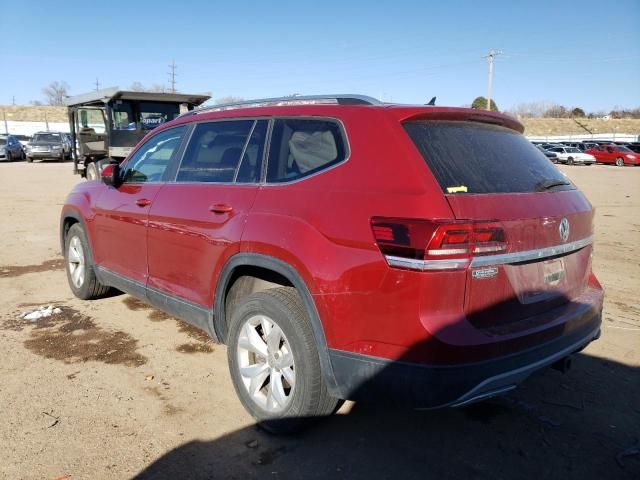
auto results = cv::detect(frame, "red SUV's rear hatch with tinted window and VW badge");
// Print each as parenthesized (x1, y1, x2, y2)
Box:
(404, 121, 593, 334)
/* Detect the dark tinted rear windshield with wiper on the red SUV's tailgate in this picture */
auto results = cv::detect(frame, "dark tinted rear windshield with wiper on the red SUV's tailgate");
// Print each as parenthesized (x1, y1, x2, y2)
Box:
(404, 121, 575, 194)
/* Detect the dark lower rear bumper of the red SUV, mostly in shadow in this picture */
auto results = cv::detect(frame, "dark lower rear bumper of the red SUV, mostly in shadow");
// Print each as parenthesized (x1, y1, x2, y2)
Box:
(330, 309, 601, 408)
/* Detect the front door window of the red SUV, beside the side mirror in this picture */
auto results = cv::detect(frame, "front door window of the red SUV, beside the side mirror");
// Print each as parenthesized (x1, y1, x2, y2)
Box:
(123, 127, 185, 183)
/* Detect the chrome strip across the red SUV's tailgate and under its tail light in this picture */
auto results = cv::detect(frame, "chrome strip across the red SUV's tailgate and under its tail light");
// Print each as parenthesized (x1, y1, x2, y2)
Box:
(385, 235, 593, 272)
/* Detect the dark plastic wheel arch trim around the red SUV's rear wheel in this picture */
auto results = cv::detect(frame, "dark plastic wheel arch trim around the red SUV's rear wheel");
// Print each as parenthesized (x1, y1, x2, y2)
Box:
(212, 253, 339, 396)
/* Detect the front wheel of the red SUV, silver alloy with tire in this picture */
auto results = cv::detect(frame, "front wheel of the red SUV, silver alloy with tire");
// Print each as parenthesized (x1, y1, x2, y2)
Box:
(64, 223, 110, 300)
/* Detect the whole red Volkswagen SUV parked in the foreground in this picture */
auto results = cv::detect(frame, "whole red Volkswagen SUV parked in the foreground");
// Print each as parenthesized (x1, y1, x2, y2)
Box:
(61, 96, 603, 432)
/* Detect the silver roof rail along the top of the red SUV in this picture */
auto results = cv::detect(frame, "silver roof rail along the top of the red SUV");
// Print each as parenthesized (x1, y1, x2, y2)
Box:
(180, 94, 382, 117)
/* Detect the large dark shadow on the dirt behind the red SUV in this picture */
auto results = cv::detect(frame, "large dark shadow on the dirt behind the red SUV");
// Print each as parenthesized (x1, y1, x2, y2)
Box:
(134, 346, 640, 480)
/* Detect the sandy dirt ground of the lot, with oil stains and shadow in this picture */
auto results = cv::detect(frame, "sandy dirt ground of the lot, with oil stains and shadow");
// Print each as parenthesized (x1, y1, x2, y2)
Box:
(0, 159, 640, 480)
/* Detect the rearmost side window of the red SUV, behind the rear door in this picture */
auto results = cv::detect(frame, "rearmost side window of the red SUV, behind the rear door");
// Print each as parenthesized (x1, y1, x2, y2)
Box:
(267, 119, 346, 183)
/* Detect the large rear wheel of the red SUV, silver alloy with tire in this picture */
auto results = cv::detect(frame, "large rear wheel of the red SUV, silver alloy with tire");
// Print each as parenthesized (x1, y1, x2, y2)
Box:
(227, 287, 339, 434)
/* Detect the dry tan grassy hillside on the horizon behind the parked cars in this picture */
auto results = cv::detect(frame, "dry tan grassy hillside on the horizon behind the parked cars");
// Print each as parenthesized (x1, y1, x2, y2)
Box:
(0, 105, 640, 136)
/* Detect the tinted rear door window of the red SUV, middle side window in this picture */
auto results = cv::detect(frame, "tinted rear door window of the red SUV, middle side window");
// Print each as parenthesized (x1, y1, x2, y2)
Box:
(176, 120, 255, 183)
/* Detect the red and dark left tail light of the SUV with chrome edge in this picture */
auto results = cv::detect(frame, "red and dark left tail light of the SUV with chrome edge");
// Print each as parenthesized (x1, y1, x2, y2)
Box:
(371, 217, 509, 270)
